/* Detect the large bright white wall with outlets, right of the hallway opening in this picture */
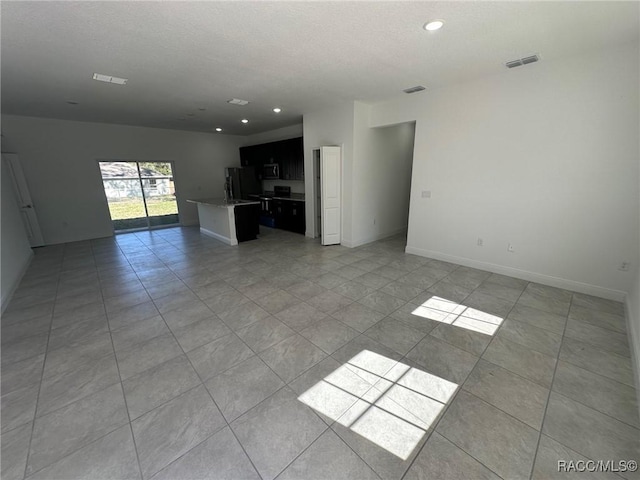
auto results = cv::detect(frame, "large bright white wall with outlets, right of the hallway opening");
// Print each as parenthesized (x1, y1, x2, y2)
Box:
(371, 44, 640, 300)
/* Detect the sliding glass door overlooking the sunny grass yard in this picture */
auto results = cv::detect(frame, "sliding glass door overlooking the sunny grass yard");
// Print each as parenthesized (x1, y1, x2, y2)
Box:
(98, 161, 180, 232)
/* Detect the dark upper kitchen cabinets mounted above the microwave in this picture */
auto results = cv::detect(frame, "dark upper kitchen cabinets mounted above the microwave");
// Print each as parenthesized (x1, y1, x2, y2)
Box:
(240, 137, 304, 180)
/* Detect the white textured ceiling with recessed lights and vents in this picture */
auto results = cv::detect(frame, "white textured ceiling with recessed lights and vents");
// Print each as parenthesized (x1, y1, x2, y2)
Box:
(1, 1, 639, 135)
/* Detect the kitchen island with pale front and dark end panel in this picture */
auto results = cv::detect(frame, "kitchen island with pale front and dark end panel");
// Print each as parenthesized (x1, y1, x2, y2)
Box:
(187, 198, 260, 245)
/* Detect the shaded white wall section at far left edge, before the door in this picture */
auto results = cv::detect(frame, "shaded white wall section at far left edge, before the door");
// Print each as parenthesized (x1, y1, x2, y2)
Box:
(0, 156, 33, 311)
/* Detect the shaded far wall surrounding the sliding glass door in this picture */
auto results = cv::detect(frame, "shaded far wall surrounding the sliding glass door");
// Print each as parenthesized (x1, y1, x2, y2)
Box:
(2, 115, 243, 244)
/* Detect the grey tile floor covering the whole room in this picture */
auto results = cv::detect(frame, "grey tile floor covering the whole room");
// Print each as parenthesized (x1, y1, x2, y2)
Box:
(1, 228, 640, 480)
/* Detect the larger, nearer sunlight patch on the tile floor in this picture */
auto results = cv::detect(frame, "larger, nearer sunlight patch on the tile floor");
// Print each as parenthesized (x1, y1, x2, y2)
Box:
(298, 350, 458, 460)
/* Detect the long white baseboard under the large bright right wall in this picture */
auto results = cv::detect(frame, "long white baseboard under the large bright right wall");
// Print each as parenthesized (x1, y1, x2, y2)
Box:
(405, 246, 626, 302)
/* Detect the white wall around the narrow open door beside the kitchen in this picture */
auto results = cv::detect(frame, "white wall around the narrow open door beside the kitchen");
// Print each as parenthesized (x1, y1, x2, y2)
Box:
(303, 102, 354, 244)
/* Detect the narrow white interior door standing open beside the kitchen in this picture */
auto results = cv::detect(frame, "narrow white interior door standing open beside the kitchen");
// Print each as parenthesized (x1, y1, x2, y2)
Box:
(320, 147, 342, 245)
